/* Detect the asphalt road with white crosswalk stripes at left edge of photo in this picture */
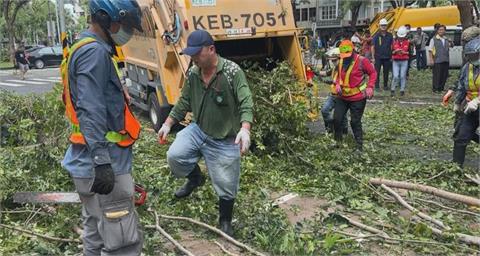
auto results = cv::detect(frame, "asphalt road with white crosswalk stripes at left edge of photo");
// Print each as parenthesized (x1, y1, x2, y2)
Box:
(0, 67, 61, 94)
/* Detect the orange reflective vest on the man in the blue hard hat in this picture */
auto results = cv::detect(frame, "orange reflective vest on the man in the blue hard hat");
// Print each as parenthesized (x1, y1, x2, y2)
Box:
(60, 37, 141, 147)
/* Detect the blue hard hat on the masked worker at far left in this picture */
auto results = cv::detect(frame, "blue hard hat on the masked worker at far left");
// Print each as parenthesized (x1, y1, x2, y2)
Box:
(88, 0, 143, 32)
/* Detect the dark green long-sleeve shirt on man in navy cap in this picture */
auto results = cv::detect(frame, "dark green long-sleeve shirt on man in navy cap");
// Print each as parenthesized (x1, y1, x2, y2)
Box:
(170, 56, 253, 139)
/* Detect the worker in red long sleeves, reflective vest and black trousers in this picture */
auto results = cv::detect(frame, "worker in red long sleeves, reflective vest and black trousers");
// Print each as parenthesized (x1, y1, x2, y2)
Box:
(333, 40, 377, 151)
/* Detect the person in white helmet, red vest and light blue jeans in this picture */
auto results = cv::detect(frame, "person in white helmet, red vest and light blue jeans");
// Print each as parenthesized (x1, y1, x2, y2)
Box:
(390, 26, 410, 97)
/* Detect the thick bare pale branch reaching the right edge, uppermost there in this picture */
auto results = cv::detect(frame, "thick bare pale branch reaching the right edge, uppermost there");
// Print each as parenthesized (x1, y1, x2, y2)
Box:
(370, 178, 480, 206)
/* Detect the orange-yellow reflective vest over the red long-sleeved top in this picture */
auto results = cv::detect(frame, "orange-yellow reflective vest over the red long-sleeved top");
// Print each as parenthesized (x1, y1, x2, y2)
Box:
(330, 55, 367, 97)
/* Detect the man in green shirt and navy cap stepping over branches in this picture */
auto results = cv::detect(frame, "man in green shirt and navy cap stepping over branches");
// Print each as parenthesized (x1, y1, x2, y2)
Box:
(158, 30, 253, 236)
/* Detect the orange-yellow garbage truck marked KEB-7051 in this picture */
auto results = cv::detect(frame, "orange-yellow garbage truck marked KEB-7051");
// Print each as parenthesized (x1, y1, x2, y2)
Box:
(122, 0, 305, 130)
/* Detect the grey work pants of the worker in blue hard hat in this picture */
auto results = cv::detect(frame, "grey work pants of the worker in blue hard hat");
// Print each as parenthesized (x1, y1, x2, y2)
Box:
(73, 174, 143, 256)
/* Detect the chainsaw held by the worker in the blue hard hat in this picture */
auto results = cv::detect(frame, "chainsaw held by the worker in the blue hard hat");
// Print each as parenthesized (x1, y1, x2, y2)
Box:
(13, 184, 147, 206)
